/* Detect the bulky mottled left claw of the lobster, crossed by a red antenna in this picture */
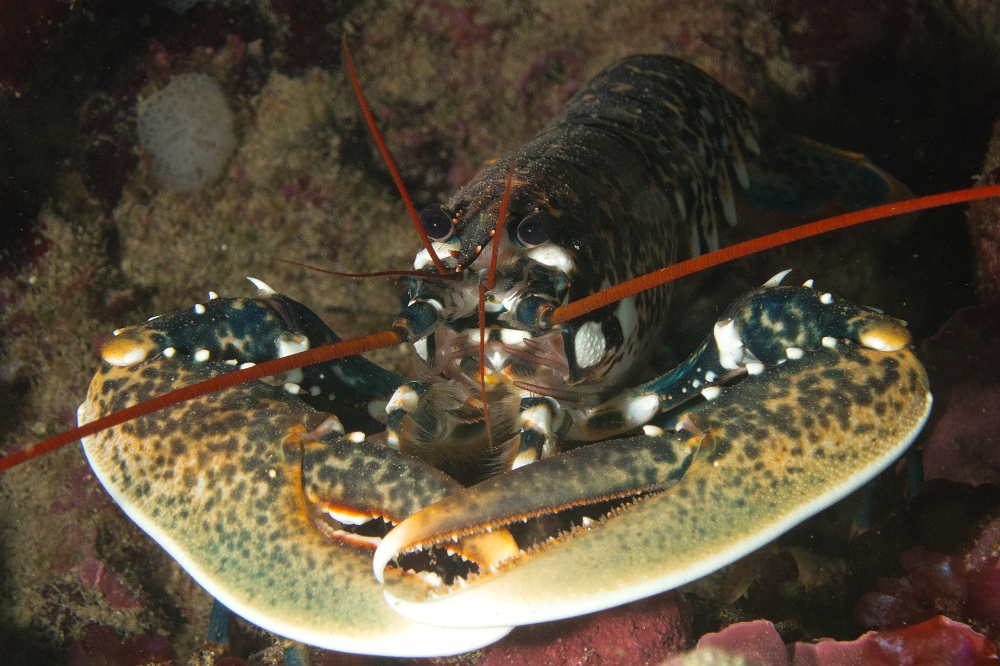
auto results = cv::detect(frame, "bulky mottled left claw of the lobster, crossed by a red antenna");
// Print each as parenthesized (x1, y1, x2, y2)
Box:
(79, 358, 509, 656)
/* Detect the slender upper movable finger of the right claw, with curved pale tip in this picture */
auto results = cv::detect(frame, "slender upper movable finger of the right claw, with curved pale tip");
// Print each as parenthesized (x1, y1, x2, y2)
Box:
(374, 426, 700, 622)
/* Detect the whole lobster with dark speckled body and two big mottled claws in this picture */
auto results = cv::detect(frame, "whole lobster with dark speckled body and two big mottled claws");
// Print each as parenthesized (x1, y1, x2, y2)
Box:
(7, 48, 968, 656)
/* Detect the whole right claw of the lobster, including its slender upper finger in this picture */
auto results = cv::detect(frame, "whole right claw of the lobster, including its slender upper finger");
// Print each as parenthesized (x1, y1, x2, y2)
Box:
(375, 341, 931, 627)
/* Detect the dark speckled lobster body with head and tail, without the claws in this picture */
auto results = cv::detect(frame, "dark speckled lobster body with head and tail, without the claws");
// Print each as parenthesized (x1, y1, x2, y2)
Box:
(382, 55, 909, 481)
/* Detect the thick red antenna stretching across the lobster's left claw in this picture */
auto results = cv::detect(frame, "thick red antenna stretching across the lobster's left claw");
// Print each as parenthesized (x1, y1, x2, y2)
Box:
(0, 329, 403, 472)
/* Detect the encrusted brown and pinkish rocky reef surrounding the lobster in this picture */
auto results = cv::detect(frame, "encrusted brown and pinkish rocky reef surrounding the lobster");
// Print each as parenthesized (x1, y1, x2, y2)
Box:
(0, 0, 1000, 664)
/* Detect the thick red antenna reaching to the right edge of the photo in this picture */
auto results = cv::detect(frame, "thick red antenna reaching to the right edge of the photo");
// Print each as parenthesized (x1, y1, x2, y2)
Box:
(549, 185, 1000, 326)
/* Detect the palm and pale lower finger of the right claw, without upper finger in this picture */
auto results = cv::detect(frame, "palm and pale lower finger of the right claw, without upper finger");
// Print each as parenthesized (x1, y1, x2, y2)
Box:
(376, 343, 931, 627)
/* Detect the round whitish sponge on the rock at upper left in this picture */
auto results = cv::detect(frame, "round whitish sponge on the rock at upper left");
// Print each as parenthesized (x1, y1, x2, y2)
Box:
(138, 74, 236, 192)
